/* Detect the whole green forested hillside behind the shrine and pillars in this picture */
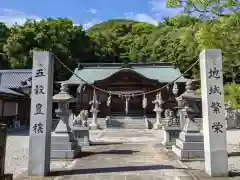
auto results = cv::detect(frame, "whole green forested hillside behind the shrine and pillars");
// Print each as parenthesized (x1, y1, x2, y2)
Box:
(0, 13, 240, 79)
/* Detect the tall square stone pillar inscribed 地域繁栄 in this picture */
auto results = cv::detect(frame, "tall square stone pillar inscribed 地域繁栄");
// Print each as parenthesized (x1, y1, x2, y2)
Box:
(200, 49, 228, 177)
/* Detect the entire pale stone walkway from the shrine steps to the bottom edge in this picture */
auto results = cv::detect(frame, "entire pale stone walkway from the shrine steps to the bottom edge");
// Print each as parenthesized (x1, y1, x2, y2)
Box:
(17, 129, 238, 180)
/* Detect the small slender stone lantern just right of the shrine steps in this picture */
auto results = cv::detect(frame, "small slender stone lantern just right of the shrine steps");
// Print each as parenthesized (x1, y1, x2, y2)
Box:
(153, 92, 164, 129)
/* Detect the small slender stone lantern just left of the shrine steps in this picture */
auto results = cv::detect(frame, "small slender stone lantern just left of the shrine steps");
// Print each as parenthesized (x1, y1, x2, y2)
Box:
(89, 90, 101, 129)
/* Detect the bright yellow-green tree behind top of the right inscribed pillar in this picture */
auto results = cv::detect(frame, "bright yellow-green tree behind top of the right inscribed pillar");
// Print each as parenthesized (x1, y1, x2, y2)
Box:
(196, 13, 240, 79)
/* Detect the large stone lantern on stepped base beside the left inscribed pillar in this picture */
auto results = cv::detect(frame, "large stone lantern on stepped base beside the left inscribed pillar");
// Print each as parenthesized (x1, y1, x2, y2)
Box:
(51, 83, 81, 159)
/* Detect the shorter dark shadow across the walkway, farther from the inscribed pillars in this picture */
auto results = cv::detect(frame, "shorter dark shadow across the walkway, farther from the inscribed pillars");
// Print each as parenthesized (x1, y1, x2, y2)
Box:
(77, 150, 140, 158)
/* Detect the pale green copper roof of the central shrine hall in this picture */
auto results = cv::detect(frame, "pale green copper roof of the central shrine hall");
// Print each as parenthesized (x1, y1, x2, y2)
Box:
(65, 64, 187, 84)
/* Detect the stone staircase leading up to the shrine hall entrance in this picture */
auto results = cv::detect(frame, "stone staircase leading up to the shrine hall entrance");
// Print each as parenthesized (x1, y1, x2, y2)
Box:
(108, 116, 148, 129)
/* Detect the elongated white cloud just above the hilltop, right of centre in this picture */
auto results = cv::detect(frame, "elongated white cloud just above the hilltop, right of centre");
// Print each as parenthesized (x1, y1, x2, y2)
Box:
(124, 12, 158, 26)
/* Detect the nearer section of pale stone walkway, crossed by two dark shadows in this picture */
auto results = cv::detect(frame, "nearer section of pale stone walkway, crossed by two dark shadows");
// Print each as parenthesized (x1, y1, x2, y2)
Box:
(53, 143, 192, 180)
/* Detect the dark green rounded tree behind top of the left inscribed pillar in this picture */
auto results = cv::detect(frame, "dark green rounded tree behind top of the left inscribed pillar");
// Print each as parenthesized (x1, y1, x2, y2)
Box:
(4, 18, 94, 79)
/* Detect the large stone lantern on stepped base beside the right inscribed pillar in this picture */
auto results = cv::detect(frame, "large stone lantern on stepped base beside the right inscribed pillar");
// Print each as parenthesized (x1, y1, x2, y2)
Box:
(172, 80, 204, 159)
